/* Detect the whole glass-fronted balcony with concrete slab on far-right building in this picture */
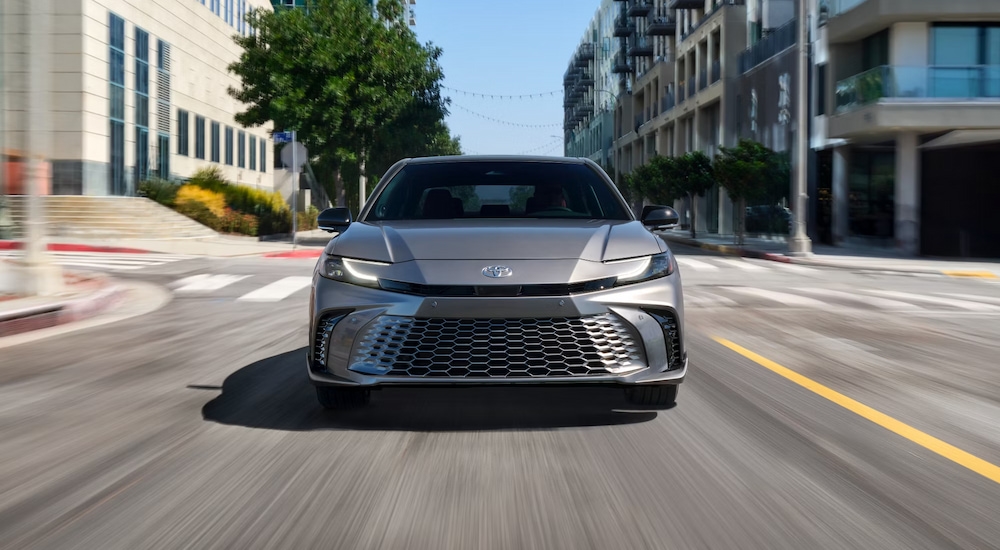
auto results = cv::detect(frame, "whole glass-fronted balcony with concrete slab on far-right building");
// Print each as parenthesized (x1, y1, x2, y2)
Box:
(829, 65, 1000, 138)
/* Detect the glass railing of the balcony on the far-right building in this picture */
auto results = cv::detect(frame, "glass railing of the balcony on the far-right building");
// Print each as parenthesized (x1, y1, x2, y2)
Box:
(836, 65, 1000, 113)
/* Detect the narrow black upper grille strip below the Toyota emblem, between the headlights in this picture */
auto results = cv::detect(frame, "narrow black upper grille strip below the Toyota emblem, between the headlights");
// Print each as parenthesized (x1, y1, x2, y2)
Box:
(379, 277, 618, 298)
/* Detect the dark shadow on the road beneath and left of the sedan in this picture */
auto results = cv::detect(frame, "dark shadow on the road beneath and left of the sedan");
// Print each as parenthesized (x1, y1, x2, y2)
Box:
(202, 348, 663, 432)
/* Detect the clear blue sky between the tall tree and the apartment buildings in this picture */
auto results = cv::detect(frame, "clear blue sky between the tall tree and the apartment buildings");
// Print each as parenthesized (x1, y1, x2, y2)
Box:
(412, 0, 600, 156)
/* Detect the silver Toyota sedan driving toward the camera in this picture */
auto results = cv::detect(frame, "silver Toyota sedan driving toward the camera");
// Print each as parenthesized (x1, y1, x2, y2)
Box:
(308, 156, 687, 409)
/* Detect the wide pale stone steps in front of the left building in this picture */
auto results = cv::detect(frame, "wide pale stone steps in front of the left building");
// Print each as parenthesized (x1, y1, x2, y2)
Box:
(4, 195, 218, 239)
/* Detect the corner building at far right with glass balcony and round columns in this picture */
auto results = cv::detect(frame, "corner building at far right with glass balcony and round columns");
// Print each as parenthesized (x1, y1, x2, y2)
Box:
(815, 0, 1000, 258)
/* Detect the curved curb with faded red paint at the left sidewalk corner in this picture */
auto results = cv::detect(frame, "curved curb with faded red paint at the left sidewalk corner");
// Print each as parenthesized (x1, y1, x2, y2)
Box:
(0, 281, 126, 338)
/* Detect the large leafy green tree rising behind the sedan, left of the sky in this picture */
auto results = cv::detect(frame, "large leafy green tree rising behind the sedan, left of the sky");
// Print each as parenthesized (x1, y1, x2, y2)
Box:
(229, 0, 450, 211)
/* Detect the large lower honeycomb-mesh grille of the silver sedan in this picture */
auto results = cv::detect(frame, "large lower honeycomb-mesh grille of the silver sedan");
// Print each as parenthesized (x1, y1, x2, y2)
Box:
(351, 314, 643, 378)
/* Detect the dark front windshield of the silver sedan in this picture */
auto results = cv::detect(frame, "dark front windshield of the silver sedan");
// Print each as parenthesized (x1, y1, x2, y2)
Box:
(365, 161, 631, 221)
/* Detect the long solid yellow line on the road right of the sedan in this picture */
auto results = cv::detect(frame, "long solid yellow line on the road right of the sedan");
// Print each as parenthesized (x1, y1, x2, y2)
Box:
(713, 337, 1000, 483)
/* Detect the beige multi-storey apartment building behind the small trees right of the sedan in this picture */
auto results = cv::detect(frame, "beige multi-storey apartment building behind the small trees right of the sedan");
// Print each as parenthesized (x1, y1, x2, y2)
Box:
(613, 0, 747, 234)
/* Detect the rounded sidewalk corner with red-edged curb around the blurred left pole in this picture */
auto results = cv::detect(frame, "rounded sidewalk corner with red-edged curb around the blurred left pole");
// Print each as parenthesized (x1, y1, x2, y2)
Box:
(0, 261, 125, 338)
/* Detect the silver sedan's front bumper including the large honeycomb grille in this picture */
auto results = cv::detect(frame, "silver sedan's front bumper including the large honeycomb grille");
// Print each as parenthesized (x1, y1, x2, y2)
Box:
(307, 273, 687, 387)
